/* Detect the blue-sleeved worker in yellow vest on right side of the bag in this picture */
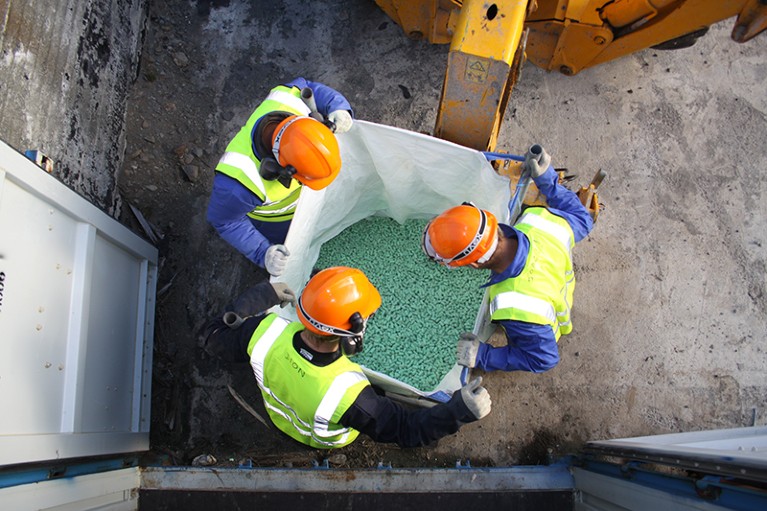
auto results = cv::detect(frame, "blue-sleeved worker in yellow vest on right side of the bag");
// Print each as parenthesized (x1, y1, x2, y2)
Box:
(422, 144, 594, 373)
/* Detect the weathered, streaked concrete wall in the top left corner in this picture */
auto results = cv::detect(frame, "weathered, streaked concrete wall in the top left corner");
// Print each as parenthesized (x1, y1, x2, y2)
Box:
(0, 0, 148, 216)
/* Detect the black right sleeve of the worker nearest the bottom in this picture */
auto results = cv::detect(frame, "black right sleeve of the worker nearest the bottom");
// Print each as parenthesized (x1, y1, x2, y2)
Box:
(340, 386, 477, 447)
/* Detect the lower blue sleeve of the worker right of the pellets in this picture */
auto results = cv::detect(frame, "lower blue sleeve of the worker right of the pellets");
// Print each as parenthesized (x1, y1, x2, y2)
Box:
(476, 321, 559, 373)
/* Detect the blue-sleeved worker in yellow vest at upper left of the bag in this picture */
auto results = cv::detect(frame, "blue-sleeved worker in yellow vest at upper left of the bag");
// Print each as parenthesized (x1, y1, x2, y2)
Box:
(207, 78, 353, 276)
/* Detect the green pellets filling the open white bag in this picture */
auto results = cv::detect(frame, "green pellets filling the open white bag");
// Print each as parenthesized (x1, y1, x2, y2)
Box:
(315, 216, 487, 392)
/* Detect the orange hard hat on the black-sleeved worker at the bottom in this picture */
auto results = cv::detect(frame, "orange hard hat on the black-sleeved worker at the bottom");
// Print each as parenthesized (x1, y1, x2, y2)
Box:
(296, 266, 381, 337)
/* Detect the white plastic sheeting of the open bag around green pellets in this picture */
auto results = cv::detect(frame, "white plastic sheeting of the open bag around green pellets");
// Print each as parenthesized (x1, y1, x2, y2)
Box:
(274, 121, 510, 401)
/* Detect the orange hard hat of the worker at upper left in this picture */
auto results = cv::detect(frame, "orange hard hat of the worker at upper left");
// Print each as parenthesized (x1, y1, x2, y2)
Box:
(272, 115, 341, 190)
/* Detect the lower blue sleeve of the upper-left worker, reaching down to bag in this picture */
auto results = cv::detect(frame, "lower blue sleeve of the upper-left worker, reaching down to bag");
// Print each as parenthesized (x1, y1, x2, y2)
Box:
(208, 172, 271, 268)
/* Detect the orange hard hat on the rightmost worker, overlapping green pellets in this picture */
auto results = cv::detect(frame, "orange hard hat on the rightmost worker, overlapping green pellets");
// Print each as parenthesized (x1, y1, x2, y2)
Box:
(421, 202, 498, 268)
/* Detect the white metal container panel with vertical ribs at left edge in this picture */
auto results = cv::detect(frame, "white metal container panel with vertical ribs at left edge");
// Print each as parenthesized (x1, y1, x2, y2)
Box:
(0, 142, 157, 465)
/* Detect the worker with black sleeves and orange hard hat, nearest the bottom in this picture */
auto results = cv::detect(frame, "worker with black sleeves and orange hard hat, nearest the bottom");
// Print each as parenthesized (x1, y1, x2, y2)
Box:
(202, 266, 492, 449)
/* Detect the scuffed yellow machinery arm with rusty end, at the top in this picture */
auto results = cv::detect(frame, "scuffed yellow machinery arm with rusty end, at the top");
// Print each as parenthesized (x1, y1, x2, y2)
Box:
(376, 0, 767, 151)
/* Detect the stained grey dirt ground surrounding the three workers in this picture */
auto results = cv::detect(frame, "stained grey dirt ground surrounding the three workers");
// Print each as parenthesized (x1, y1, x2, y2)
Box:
(119, 0, 767, 468)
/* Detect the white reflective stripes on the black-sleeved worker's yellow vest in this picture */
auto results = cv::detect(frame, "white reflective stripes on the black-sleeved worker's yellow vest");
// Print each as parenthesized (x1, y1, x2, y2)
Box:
(250, 315, 367, 448)
